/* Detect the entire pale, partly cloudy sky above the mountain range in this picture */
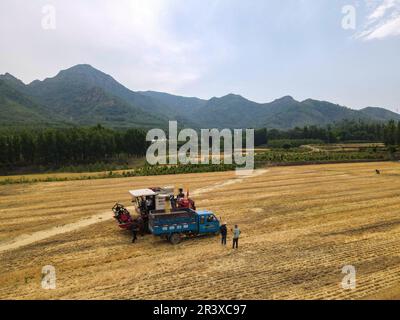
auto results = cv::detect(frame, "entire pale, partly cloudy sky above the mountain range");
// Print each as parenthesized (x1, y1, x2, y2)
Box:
(0, 0, 400, 112)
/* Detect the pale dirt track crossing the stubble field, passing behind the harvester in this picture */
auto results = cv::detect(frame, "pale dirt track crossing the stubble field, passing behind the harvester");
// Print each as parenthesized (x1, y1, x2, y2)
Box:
(0, 169, 268, 253)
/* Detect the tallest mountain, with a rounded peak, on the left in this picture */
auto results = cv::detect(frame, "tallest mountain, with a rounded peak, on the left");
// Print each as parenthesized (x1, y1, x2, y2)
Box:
(0, 65, 165, 127)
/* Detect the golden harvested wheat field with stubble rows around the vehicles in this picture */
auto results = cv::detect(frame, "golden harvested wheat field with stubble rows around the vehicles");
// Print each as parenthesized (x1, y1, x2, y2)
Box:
(0, 162, 400, 299)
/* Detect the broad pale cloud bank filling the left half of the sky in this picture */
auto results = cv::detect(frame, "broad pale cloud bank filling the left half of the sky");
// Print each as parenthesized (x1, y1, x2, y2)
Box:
(0, 0, 227, 92)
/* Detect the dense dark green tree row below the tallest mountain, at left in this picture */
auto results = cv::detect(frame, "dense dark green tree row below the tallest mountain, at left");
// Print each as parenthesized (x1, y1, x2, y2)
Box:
(0, 126, 147, 166)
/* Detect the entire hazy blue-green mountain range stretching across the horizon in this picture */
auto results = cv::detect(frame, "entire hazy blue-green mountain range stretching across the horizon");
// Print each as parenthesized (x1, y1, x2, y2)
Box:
(0, 65, 400, 129)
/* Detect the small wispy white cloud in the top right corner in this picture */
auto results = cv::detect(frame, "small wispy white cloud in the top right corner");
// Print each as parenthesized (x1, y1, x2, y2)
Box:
(356, 0, 400, 41)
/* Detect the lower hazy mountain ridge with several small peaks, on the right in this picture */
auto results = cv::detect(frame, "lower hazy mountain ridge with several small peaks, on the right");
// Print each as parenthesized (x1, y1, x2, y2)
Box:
(195, 94, 400, 129)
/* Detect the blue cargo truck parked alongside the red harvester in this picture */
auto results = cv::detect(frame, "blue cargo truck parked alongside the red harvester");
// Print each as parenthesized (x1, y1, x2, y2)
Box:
(149, 208, 220, 244)
